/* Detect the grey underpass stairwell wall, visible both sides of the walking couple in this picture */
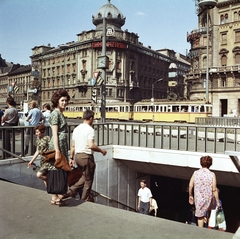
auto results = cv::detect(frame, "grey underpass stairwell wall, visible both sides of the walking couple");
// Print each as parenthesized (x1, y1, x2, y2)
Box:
(0, 146, 137, 209)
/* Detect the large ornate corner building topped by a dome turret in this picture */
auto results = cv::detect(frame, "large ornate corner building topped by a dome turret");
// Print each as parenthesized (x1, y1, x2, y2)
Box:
(30, 0, 189, 107)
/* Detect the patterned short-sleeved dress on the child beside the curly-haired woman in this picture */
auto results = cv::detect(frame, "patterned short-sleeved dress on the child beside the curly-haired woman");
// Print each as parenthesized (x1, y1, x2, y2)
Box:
(36, 136, 55, 174)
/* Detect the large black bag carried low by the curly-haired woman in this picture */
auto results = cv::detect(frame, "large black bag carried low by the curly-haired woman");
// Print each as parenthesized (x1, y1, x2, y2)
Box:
(47, 169, 68, 194)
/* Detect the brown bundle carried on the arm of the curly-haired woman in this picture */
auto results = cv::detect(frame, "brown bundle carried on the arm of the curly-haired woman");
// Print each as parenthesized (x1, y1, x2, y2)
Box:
(42, 150, 71, 171)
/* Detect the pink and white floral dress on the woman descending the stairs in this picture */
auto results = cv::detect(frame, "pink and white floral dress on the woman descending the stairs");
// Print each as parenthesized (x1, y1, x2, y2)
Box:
(193, 168, 214, 217)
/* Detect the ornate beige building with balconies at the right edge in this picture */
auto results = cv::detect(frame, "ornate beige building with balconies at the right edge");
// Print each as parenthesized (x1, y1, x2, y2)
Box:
(186, 0, 240, 116)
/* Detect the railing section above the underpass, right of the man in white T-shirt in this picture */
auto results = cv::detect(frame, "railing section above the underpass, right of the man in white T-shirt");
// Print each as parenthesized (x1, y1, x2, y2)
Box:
(94, 122, 240, 154)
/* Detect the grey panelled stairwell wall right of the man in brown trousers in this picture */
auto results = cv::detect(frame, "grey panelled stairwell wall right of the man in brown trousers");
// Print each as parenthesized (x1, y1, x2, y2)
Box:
(92, 146, 137, 211)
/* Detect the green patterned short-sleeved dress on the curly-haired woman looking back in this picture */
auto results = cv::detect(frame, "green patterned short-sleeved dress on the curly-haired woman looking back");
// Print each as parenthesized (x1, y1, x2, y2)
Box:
(48, 109, 68, 158)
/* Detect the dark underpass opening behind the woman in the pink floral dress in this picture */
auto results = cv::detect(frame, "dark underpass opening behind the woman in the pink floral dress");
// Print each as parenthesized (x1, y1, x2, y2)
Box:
(148, 175, 240, 233)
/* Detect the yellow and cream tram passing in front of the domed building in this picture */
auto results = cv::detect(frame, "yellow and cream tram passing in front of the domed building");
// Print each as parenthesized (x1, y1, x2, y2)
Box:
(64, 101, 212, 123)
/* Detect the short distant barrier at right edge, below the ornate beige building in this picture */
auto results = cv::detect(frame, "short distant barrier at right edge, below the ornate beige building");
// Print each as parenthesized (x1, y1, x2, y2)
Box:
(195, 117, 240, 127)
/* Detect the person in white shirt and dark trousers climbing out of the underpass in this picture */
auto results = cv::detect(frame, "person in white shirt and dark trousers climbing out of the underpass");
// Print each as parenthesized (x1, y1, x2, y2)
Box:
(138, 180, 152, 214)
